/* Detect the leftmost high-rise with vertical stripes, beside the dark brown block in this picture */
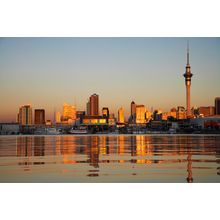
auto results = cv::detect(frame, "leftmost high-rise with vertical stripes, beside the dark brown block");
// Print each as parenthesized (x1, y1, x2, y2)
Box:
(18, 105, 32, 125)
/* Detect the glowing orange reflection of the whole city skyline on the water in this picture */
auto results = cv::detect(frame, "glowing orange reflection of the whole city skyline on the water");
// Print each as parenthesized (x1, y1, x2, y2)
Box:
(12, 135, 220, 182)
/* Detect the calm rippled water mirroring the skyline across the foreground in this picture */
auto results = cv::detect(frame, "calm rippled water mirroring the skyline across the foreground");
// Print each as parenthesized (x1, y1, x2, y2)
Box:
(0, 135, 220, 182)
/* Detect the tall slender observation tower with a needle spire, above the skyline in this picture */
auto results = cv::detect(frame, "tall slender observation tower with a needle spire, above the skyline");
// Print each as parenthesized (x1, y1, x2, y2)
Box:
(183, 42, 193, 118)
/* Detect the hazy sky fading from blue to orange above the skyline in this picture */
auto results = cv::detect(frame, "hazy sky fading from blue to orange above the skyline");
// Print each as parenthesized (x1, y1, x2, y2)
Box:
(0, 38, 220, 122)
